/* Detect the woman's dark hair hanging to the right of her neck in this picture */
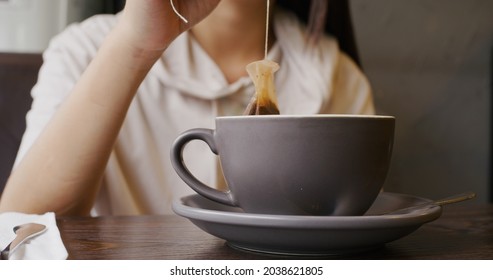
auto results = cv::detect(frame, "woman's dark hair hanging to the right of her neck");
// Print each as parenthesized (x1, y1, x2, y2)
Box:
(276, 0, 360, 65)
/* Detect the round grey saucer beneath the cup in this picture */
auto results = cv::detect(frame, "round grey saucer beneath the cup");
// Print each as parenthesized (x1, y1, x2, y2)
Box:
(173, 192, 442, 255)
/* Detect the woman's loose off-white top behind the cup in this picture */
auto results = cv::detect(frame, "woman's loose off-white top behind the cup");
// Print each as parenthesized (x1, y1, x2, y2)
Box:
(16, 8, 374, 215)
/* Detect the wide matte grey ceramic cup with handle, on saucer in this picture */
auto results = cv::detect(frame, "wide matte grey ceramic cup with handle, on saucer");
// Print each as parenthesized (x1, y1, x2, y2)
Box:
(171, 115, 395, 216)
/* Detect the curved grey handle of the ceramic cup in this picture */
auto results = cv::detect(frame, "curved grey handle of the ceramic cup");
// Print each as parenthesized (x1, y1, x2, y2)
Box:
(171, 128, 238, 206)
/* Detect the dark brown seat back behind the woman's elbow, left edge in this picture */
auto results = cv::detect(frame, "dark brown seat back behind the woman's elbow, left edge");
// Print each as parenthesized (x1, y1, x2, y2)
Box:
(0, 53, 42, 193)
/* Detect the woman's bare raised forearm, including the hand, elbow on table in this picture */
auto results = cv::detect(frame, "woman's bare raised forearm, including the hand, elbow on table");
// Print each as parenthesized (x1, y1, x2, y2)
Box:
(0, 0, 219, 215)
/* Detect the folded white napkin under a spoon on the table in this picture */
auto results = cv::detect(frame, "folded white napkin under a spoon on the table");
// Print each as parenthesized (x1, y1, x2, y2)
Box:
(0, 212, 68, 260)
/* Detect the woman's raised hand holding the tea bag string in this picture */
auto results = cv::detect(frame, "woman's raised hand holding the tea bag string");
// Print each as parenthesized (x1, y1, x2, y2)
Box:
(119, 0, 220, 52)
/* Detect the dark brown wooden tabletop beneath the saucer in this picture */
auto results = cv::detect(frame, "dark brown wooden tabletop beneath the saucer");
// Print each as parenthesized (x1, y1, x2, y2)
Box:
(58, 203, 493, 260)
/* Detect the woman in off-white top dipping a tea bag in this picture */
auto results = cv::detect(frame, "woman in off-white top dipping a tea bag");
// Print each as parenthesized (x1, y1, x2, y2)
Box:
(0, 0, 374, 215)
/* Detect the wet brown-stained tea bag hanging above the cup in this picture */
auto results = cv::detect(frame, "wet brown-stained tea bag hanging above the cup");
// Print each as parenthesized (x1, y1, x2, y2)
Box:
(244, 59, 280, 115)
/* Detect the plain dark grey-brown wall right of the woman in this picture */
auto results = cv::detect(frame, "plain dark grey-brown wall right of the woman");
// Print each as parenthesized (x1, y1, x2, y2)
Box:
(351, 0, 493, 202)
